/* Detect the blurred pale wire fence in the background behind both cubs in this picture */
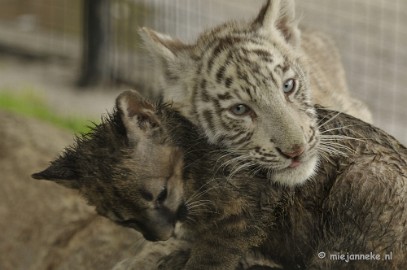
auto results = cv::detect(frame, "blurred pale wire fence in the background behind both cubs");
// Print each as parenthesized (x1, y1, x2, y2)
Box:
(0, 0, 407, 144)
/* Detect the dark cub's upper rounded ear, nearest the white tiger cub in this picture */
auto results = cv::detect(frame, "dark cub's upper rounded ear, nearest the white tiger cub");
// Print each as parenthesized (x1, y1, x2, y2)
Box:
(116, 90, 160, 142)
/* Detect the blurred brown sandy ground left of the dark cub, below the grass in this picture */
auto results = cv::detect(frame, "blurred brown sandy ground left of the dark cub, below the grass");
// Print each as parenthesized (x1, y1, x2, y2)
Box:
(0, 110, 143, 270)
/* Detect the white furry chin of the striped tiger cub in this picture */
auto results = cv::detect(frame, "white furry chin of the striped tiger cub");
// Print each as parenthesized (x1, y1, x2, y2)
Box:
(270, 155, 318, 186)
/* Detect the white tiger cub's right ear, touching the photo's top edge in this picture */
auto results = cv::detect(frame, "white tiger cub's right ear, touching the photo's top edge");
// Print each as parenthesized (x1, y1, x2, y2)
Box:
(253, 0, 301, 48)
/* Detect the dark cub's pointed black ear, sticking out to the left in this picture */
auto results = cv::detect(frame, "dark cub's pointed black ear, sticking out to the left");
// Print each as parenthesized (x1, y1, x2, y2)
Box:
(31, 150, 79, 189)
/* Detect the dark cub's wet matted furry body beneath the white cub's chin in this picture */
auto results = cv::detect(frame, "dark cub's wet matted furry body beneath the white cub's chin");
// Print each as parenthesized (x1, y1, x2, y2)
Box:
(35, 91, 407, 269)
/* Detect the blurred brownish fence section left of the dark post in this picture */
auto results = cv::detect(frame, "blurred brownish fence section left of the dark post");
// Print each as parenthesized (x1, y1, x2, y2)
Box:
(0, 0, 82, 61)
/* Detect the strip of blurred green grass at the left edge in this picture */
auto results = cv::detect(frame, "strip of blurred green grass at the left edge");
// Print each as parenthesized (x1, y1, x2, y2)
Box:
(0, 91, 92, 133)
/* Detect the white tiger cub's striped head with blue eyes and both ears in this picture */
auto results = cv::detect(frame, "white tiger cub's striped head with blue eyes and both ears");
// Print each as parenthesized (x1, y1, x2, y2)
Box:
(140, 0, 370, 186)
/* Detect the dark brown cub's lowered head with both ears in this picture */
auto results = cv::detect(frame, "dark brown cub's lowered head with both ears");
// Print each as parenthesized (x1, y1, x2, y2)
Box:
(32, 91, 183, 241)
